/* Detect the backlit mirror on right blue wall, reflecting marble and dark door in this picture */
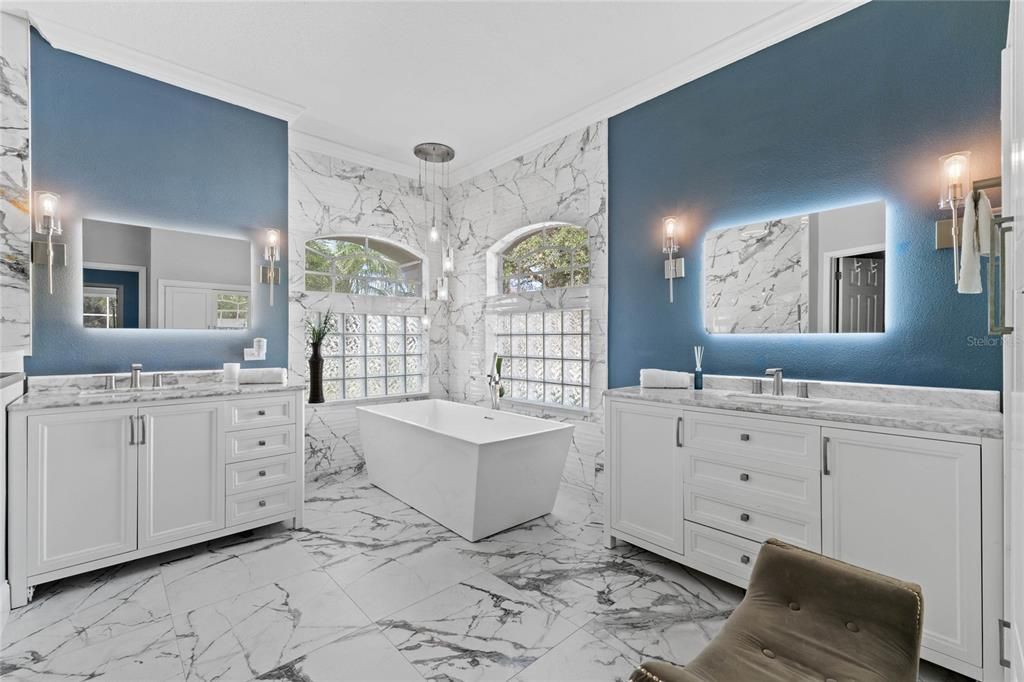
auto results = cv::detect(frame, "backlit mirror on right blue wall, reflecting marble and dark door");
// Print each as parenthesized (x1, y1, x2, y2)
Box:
(703, 197, 886, 334)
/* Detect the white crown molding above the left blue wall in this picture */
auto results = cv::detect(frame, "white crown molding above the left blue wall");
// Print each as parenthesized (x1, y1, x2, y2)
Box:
(26, 11, 305, 123)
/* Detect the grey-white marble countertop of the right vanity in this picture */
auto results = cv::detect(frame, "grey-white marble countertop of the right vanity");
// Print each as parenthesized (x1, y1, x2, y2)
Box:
(604, 386, 1002, 438)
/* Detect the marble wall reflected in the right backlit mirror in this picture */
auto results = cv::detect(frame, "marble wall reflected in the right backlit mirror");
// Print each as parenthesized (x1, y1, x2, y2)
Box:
(703, 215, 810, 334)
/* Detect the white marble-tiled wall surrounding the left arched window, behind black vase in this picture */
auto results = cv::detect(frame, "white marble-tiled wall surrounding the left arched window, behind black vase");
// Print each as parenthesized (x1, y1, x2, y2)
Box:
(288, 146, 449, 477)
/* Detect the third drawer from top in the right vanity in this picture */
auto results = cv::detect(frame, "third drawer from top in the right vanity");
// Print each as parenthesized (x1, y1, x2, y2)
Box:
(683, 483, 821, 552)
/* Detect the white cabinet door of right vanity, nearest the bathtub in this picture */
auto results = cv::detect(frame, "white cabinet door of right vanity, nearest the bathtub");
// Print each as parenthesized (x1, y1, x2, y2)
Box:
(607, 401, 686, 554)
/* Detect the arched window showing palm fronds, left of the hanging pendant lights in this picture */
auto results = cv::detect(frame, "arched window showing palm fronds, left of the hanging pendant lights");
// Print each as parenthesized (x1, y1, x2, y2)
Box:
(306, 237, 423, 296)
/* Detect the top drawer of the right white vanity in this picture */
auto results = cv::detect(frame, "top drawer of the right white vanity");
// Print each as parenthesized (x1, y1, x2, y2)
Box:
(683, 412, 821, 469)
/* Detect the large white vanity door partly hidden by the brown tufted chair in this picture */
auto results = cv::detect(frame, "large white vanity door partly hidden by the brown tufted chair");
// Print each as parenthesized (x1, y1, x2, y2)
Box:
(821, 428, 982, 666)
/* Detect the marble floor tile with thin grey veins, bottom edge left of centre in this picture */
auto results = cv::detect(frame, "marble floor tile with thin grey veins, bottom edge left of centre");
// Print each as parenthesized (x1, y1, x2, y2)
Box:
(174, 569, 370, 680)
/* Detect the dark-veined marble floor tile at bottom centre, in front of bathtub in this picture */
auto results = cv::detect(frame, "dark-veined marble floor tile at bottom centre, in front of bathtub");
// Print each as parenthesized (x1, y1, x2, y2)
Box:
(378, 572, 577, 680)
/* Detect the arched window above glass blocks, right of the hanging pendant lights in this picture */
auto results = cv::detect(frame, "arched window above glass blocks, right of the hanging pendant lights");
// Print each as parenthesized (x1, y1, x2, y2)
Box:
(501, 224, 590, 294)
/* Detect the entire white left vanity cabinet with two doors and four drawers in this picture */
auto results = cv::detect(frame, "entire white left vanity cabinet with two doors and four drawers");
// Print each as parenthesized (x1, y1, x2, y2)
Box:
(7, 387, 304, 607)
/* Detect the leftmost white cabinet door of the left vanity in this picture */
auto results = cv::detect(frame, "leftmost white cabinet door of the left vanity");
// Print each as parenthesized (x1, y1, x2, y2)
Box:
(27, 408, 137, 576)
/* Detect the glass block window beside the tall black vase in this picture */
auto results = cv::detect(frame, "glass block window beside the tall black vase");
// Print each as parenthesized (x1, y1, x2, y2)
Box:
(306, 313, 427, 400)
